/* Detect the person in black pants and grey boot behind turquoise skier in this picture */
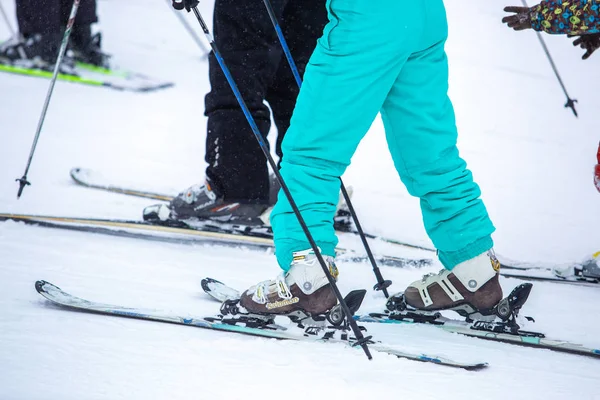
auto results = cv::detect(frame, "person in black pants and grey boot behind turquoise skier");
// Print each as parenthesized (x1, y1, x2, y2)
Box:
(144, 0, 328, 224)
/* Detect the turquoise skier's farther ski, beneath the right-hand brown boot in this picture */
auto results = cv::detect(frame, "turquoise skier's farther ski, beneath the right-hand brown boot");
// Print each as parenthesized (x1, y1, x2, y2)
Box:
(201, 278, 600, 358)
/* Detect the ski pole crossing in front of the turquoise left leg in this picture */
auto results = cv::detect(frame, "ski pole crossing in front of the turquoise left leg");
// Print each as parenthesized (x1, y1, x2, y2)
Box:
(173, 0, 373, 360)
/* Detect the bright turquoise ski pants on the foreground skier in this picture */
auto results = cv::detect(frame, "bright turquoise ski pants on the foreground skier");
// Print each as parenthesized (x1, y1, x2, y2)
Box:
(271, 0, 494, 270)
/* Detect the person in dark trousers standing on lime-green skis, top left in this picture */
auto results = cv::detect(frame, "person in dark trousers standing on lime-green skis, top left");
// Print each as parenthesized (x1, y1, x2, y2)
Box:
(0, 0, 108, 69)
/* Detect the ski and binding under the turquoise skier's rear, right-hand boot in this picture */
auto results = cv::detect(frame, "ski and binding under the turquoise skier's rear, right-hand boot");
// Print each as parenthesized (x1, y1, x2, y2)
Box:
(201, 278, 600, 358)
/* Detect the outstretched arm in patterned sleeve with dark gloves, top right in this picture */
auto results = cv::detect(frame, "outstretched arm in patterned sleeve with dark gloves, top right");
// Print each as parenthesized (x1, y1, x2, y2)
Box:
(502, 0, 600, 60)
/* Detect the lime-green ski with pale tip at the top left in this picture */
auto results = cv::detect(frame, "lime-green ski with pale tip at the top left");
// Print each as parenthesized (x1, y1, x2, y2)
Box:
(0, 60, 173, 92)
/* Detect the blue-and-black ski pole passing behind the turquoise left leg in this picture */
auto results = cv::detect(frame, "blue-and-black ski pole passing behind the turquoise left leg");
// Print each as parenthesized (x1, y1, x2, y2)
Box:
(263, 0, 392, 298)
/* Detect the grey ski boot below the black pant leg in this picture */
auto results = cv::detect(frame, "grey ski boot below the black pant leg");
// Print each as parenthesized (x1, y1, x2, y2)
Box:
(144, 178, 270, 226)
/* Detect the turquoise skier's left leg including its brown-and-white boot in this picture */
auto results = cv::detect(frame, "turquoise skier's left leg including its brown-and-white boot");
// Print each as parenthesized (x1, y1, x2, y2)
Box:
(240, 0, 429, 313)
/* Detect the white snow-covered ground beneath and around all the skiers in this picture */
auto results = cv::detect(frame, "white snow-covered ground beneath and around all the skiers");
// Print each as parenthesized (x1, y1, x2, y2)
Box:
(0, 0, 600, 399)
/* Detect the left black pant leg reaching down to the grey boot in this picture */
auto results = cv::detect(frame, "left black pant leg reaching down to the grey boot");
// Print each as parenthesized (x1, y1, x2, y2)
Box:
(205, 0, 287, 202)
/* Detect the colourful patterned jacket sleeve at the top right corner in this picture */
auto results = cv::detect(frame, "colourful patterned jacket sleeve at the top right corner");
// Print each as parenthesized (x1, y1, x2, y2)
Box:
(531, 0, 600, 35)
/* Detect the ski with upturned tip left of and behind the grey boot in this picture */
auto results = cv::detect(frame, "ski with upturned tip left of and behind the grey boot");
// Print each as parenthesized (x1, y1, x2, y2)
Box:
(70, 168, 435, 252)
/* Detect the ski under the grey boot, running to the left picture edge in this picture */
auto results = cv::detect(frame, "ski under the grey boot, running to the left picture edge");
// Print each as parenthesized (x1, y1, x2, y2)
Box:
(0, 213, 432, 268)
